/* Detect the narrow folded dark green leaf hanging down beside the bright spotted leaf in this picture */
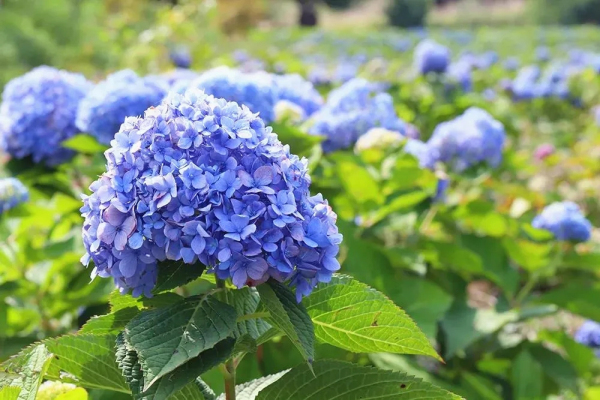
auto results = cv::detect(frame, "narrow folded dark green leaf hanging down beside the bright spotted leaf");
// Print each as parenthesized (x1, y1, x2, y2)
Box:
(257, 280, 315, 363)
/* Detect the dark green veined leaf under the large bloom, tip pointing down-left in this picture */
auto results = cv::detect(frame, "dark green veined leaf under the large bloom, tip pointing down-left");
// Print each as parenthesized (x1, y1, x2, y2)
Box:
(125, 297, 237, 390)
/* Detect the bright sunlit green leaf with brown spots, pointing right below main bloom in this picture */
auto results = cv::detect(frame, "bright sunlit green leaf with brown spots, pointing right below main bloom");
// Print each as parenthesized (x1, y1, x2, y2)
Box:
(305, 275, 441, 360)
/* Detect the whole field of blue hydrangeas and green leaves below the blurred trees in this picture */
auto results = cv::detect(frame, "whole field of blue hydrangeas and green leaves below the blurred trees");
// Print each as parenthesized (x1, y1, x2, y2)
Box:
(0, 7, 600, 400)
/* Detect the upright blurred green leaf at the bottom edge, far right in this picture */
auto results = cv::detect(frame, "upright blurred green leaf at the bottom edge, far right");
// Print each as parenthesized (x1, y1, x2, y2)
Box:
(511, 350, 545, 400)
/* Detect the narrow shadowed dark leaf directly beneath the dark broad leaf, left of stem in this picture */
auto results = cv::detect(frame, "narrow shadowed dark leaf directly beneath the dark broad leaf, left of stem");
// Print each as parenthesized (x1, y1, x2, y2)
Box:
(139, 338, 235, 400)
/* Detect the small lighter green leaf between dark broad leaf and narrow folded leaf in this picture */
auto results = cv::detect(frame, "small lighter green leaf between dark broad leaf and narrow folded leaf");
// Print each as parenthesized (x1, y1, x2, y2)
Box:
(228, 287, 271, 342)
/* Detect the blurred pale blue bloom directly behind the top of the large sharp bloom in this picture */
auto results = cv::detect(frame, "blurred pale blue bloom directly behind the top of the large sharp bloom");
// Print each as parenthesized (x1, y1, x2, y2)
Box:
(190, 67, 277, 123)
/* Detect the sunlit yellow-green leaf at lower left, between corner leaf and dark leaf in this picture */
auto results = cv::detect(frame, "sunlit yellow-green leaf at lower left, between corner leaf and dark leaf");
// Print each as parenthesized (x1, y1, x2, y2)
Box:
(44, 334, 129, 393)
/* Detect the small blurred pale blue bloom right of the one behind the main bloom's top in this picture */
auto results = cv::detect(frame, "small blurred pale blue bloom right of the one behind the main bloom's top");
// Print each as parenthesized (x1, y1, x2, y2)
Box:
(274, 74, 323, 117)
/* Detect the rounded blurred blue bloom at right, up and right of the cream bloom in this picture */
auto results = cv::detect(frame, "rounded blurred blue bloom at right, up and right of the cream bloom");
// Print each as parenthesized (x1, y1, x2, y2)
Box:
(427, 107, 506, 172)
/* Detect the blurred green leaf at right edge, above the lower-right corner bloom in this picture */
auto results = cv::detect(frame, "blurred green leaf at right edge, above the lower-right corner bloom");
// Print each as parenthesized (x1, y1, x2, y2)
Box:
(536, 281, 600, 321)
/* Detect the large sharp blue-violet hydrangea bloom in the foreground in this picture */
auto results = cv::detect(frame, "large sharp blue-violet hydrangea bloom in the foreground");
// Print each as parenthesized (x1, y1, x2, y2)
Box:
(81, 89, 342, 299)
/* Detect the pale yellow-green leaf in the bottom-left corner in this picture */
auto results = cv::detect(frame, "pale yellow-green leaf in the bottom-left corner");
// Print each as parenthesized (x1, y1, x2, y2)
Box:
(0, 344, 52, 400)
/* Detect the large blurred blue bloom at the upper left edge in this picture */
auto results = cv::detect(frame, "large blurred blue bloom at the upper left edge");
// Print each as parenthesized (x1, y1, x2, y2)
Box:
(0, 66, 92, 165)
